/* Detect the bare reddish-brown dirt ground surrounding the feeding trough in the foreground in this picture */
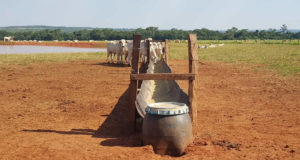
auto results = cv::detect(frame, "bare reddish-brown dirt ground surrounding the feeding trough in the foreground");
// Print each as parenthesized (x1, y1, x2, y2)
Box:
(0, 60, 300, 159)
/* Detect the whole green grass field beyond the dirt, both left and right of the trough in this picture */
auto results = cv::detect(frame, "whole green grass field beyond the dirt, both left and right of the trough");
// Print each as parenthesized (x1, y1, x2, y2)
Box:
(0, 41, 300, 75)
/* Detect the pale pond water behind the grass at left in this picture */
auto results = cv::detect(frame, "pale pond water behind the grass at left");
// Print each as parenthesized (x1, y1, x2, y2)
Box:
(0, 45, 106, 54)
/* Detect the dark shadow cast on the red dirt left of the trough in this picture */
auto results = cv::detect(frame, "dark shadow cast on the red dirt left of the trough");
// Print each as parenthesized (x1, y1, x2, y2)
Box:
(22, 89, 142, 147)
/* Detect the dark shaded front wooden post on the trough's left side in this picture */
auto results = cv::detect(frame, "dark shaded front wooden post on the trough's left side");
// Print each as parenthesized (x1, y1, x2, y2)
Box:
(128, 34, 142, 133)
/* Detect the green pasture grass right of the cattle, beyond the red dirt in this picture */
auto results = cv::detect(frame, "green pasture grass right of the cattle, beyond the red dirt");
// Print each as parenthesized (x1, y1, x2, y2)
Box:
(169, 43, 300, 75)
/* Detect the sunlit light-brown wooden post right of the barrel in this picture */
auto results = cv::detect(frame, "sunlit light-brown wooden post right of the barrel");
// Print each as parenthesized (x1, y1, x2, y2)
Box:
(188, 34, 198, 135)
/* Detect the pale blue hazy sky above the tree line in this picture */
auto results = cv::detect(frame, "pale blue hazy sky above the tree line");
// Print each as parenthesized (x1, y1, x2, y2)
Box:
(0, 0, 300, 30)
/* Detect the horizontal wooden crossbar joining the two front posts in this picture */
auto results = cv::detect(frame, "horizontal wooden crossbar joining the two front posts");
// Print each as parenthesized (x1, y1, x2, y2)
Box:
(130, 73, 195, 80)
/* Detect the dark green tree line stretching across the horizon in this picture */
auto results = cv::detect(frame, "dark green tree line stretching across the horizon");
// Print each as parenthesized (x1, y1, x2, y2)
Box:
(0, 25, 300, 41)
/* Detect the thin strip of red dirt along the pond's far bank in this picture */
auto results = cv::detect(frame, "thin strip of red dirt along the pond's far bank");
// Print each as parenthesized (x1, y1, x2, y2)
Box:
(0, 41, 106, 48)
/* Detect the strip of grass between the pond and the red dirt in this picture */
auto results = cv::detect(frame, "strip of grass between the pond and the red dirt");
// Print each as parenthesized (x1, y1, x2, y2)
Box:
(0, 52, 106, 65)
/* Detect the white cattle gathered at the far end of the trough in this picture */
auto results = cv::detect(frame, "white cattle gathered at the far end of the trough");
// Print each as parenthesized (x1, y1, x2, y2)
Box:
(107, 38, 165, 65)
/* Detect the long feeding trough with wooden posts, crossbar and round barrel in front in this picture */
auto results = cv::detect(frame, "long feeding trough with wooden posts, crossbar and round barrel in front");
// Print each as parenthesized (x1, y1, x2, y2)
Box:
(129, 34, 198, 156)
